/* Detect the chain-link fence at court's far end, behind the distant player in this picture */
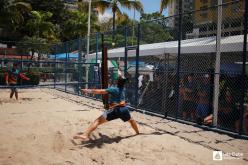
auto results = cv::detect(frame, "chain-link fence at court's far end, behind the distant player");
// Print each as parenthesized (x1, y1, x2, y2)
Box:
(0, 38, 101, 95)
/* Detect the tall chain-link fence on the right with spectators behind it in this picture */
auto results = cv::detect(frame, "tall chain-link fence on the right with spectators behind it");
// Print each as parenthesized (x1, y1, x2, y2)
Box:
(103, 0, 248, 135)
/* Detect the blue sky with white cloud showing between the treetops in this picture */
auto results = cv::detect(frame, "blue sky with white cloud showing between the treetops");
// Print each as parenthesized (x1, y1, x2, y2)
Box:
(99, 0, 168, 20)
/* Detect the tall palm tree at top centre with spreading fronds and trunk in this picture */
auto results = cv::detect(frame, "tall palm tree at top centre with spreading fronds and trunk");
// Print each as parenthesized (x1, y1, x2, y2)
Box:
(92, 0, 143, 30)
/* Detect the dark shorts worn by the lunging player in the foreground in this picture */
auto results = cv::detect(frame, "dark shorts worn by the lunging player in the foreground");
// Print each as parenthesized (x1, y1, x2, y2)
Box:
(103, 106, 131, 122)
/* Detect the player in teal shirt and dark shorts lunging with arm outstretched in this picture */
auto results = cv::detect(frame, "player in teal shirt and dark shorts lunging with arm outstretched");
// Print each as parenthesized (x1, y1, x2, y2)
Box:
(73, 77, 139, 141)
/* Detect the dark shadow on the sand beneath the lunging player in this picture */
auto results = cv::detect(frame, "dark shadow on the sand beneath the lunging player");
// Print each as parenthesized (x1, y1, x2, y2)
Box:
(71, 132, 163, 149)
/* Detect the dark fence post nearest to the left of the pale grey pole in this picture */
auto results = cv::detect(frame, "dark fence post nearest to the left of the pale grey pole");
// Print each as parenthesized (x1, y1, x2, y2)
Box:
(176, 0, 182, 119)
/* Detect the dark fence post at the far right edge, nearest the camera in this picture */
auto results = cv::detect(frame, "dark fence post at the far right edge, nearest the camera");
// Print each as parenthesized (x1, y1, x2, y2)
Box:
(239, 1, 248, 135)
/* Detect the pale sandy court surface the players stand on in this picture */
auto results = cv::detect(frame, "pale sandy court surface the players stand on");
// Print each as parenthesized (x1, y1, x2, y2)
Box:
(0, 89, 248, 165)
